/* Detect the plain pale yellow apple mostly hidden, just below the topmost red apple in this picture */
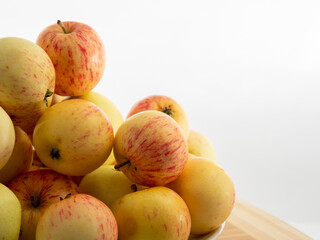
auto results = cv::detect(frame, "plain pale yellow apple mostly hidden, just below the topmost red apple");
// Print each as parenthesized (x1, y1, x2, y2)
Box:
(73, 92, 123, 165)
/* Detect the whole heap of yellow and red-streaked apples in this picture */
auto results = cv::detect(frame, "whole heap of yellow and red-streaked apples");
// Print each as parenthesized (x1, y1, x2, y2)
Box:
(0, 21, 235, 240)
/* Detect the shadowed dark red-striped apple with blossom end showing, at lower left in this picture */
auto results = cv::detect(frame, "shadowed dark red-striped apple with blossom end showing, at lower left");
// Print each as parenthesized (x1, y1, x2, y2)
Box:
(8, 169, 80, 240)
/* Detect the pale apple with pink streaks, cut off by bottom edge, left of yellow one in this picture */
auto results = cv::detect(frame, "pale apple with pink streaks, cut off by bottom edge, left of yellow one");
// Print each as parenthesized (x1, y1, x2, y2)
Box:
(36, 194, 118, 240)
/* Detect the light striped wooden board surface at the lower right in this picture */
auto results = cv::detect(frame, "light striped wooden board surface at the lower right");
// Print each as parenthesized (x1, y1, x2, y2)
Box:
(218, 200, 312, 240)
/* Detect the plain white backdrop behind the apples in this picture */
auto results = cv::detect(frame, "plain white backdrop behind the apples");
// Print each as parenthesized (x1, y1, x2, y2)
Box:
(0, 0, 320, 239)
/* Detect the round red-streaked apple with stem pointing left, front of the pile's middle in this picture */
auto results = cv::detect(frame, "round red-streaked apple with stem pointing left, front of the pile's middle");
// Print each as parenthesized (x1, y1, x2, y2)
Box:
(114, 110, 188, 187)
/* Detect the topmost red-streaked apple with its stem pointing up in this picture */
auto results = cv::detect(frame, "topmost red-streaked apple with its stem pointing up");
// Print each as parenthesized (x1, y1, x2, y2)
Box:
(36, 21, 106, 96)
